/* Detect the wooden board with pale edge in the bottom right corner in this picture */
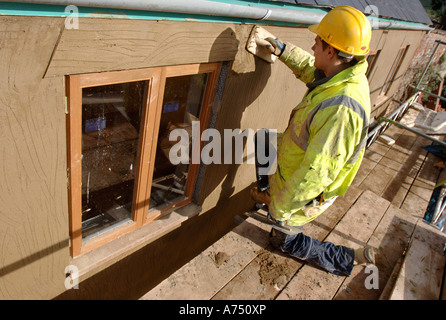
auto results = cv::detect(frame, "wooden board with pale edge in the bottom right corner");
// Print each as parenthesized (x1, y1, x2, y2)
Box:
(389, 219, 446, 300)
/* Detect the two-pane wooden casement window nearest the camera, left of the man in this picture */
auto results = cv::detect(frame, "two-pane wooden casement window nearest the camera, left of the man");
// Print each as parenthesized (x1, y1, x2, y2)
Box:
(66, 63, 220, 257)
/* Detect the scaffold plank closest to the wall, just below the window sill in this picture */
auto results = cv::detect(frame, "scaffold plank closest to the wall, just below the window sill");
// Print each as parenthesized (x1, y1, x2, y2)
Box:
(141, 218, 269, 300)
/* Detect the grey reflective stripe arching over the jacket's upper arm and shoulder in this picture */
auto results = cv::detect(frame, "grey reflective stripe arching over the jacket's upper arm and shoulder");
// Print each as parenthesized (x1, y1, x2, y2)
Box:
(291, 95, 369, 164)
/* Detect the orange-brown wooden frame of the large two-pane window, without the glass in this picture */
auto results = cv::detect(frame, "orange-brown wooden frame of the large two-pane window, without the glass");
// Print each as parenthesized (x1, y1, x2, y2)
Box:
(66, 63, 221, 258)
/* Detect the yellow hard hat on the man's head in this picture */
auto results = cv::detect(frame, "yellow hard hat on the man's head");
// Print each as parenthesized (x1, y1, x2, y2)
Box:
(309, 6, 372, 56)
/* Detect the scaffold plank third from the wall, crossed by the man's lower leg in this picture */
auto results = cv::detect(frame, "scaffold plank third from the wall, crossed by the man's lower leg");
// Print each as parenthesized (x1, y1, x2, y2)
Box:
(277, 190, 390, 300)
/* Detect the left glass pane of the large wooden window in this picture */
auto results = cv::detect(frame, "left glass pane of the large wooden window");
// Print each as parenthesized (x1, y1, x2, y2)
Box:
(82, 81, 146, 239)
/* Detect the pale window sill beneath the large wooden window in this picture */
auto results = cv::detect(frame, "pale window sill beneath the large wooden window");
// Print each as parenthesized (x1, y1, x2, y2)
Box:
(70, 203, 201, 281)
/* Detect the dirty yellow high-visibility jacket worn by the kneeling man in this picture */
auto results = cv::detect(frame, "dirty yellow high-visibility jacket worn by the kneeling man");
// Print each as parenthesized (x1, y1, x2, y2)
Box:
(269, 44, 370, 226)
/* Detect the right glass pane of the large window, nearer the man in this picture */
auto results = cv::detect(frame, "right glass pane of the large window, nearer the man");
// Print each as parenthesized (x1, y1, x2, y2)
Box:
(149, 74, 208, 210)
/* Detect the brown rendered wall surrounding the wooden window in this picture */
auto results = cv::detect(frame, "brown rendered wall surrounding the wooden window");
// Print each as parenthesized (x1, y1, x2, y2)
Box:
(0, 16, 424, 299)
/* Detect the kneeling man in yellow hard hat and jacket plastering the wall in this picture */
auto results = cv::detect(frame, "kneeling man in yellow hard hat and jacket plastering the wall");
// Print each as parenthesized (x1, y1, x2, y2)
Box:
(251, 6, 374, 276)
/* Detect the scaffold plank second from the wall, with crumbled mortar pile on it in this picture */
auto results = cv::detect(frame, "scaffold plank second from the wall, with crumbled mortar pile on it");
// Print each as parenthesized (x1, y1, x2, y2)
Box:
(213, 187, 362, 300)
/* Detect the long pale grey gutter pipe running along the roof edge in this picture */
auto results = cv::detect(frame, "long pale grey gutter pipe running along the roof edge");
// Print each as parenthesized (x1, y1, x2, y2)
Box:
(5, 0, 432, 31)
